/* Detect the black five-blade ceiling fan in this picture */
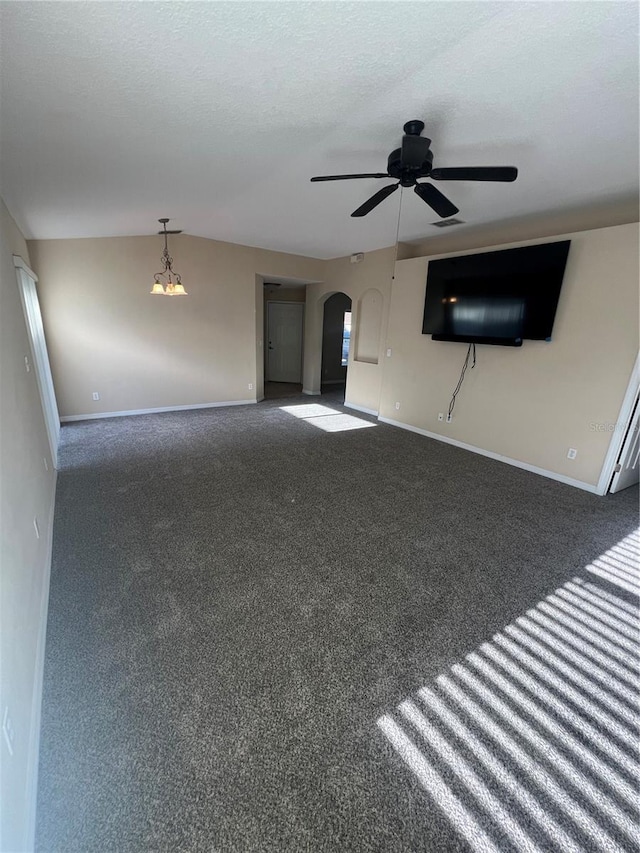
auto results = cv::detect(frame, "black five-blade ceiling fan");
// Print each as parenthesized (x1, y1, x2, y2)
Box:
(311, 119, 518, 217)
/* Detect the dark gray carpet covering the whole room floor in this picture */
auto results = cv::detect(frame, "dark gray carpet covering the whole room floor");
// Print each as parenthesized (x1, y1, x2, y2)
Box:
(36, 397, 638, 853)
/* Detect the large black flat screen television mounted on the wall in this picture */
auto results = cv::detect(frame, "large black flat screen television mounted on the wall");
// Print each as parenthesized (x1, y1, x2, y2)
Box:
(422, 240, 571, 347)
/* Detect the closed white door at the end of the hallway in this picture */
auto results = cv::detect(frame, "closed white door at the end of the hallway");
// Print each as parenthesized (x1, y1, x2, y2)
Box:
(267, 302, 304, 382)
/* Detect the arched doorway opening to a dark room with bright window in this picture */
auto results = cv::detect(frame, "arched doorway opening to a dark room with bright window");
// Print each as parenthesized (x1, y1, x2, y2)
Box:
(320, 293, 352, 404)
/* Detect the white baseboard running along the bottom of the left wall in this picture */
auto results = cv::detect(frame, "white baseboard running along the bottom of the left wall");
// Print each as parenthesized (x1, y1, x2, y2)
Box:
(23, 468, 58, 850)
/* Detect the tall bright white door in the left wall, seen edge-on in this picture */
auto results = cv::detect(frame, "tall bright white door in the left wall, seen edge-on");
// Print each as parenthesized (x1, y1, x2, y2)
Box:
(13, 255, 60, 468)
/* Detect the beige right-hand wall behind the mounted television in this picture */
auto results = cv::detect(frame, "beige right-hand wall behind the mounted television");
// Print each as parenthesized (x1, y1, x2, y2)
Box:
(380, 220, 638, 485)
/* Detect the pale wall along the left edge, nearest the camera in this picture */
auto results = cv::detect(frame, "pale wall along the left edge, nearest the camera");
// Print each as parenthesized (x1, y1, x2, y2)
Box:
(0, 202, 55, 851)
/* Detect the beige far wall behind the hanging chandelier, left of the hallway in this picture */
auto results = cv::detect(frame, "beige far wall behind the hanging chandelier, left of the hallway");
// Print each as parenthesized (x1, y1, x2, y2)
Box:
(29, 234, 323, 417)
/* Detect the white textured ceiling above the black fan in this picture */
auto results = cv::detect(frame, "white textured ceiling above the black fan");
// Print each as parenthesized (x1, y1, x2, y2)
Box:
(0, 0, 638, 257)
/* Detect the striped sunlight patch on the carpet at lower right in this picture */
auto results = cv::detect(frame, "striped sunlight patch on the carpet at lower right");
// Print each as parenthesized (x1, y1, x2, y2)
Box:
(377, 532, 640, 853)
